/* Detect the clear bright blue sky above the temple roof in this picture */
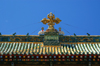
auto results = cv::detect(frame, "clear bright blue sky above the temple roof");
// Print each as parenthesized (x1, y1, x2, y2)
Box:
(0, 0, 100, 35)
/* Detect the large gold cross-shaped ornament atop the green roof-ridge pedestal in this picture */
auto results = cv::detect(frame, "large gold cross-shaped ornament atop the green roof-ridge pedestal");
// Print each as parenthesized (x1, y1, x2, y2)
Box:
(41, 13, 61, 32)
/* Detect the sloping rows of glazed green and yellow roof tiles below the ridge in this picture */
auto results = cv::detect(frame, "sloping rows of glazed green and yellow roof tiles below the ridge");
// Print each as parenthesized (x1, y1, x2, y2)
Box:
(0, 43, 100, 55)
